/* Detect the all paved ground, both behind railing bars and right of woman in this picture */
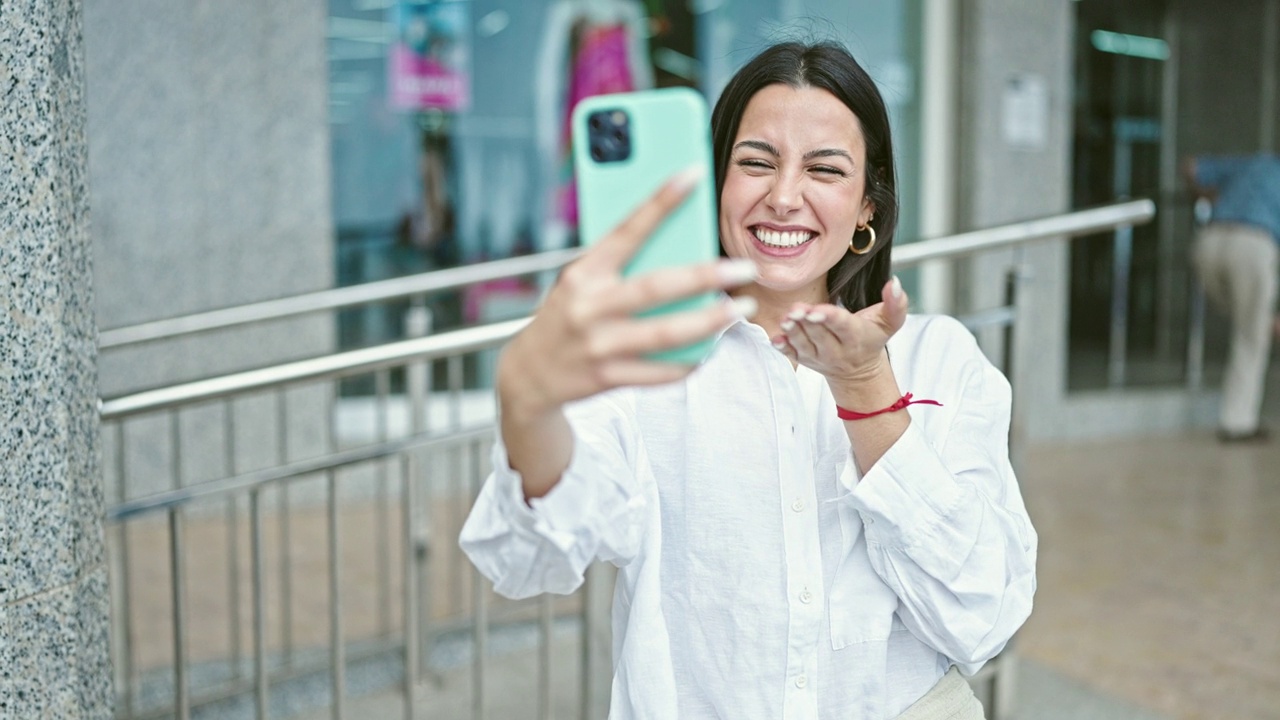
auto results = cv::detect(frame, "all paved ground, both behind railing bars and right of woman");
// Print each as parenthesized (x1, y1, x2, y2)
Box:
(112, 412, 1280, 720)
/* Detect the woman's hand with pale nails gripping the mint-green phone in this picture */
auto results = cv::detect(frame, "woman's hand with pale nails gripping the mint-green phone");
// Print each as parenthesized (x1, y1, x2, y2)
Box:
(497, 170, 755, 423)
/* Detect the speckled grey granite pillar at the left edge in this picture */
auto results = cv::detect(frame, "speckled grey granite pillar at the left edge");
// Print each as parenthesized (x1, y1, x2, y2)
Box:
(0, 0, 111, 719)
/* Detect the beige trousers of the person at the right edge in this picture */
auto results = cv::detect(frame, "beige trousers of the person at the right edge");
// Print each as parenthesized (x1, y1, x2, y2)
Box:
(1192, 223, 1280, 433)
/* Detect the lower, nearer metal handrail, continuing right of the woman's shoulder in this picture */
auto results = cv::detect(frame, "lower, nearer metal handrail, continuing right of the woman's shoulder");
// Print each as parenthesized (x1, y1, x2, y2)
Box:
(100, 200, 1156, 420)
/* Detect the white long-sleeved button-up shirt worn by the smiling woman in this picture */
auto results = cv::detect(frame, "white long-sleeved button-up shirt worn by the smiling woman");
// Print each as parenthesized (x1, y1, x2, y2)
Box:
(461, 315, 1037, 720)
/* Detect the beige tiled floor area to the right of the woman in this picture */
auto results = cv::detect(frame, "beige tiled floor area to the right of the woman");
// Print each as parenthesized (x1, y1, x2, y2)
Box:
(1019, 433, 1280, 720)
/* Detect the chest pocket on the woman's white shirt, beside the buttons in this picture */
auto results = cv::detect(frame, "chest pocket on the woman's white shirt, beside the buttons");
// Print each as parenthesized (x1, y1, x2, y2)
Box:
(827, 497, 899, 650)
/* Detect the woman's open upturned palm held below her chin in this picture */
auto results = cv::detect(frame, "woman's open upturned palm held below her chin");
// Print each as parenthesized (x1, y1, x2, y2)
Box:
(771, 277, 908, 386)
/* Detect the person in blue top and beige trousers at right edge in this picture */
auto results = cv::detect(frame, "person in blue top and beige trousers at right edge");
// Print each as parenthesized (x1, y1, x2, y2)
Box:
(1183, 154, 1280, 442)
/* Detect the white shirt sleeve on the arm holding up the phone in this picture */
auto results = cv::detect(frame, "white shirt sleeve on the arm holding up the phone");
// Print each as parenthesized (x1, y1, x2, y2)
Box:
(458, 396, 646, 598)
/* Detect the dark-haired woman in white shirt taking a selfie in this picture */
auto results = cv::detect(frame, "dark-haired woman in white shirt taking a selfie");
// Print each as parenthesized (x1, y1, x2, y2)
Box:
(462, 44, 1036, 720)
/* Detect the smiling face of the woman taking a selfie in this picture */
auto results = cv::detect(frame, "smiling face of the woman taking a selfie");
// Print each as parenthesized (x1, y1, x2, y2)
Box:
(719, 85, 874, 302)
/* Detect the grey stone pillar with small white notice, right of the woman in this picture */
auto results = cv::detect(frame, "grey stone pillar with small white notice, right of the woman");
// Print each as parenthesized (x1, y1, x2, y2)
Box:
(956, 0, 1074, 441)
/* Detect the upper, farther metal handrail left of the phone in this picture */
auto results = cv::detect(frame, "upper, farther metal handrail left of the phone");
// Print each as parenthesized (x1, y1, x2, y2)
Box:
(97, 247, 581, 350)
